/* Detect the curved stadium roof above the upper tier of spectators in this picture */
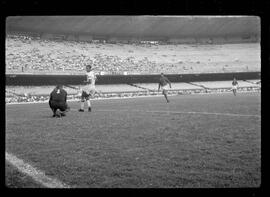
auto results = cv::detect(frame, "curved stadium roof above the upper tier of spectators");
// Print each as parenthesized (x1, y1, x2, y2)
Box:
(6, 16, 260, 38)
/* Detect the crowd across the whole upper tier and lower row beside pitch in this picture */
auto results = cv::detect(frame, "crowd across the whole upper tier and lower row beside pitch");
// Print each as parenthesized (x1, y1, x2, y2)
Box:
(5, 34, 260, 103)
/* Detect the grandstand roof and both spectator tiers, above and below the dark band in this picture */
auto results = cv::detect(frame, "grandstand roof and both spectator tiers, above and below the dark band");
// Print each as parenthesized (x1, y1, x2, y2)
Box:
(5, 16, 261, 103)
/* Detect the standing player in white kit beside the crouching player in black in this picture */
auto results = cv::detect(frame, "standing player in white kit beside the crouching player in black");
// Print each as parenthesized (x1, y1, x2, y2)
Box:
(79, 65, 96, 112)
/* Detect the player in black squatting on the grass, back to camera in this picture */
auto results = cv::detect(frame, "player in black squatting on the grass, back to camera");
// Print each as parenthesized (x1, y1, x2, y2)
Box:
(49, 85, 70, 117)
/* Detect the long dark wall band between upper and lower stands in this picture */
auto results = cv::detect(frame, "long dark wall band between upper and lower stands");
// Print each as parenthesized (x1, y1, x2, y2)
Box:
(6, 72, 261, 86)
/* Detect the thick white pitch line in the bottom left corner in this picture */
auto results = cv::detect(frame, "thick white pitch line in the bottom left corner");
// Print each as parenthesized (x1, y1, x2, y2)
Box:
(6, 152, 71, 188)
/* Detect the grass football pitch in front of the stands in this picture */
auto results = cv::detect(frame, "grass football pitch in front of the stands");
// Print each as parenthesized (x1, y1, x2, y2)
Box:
(5, 92, 261, 188)
